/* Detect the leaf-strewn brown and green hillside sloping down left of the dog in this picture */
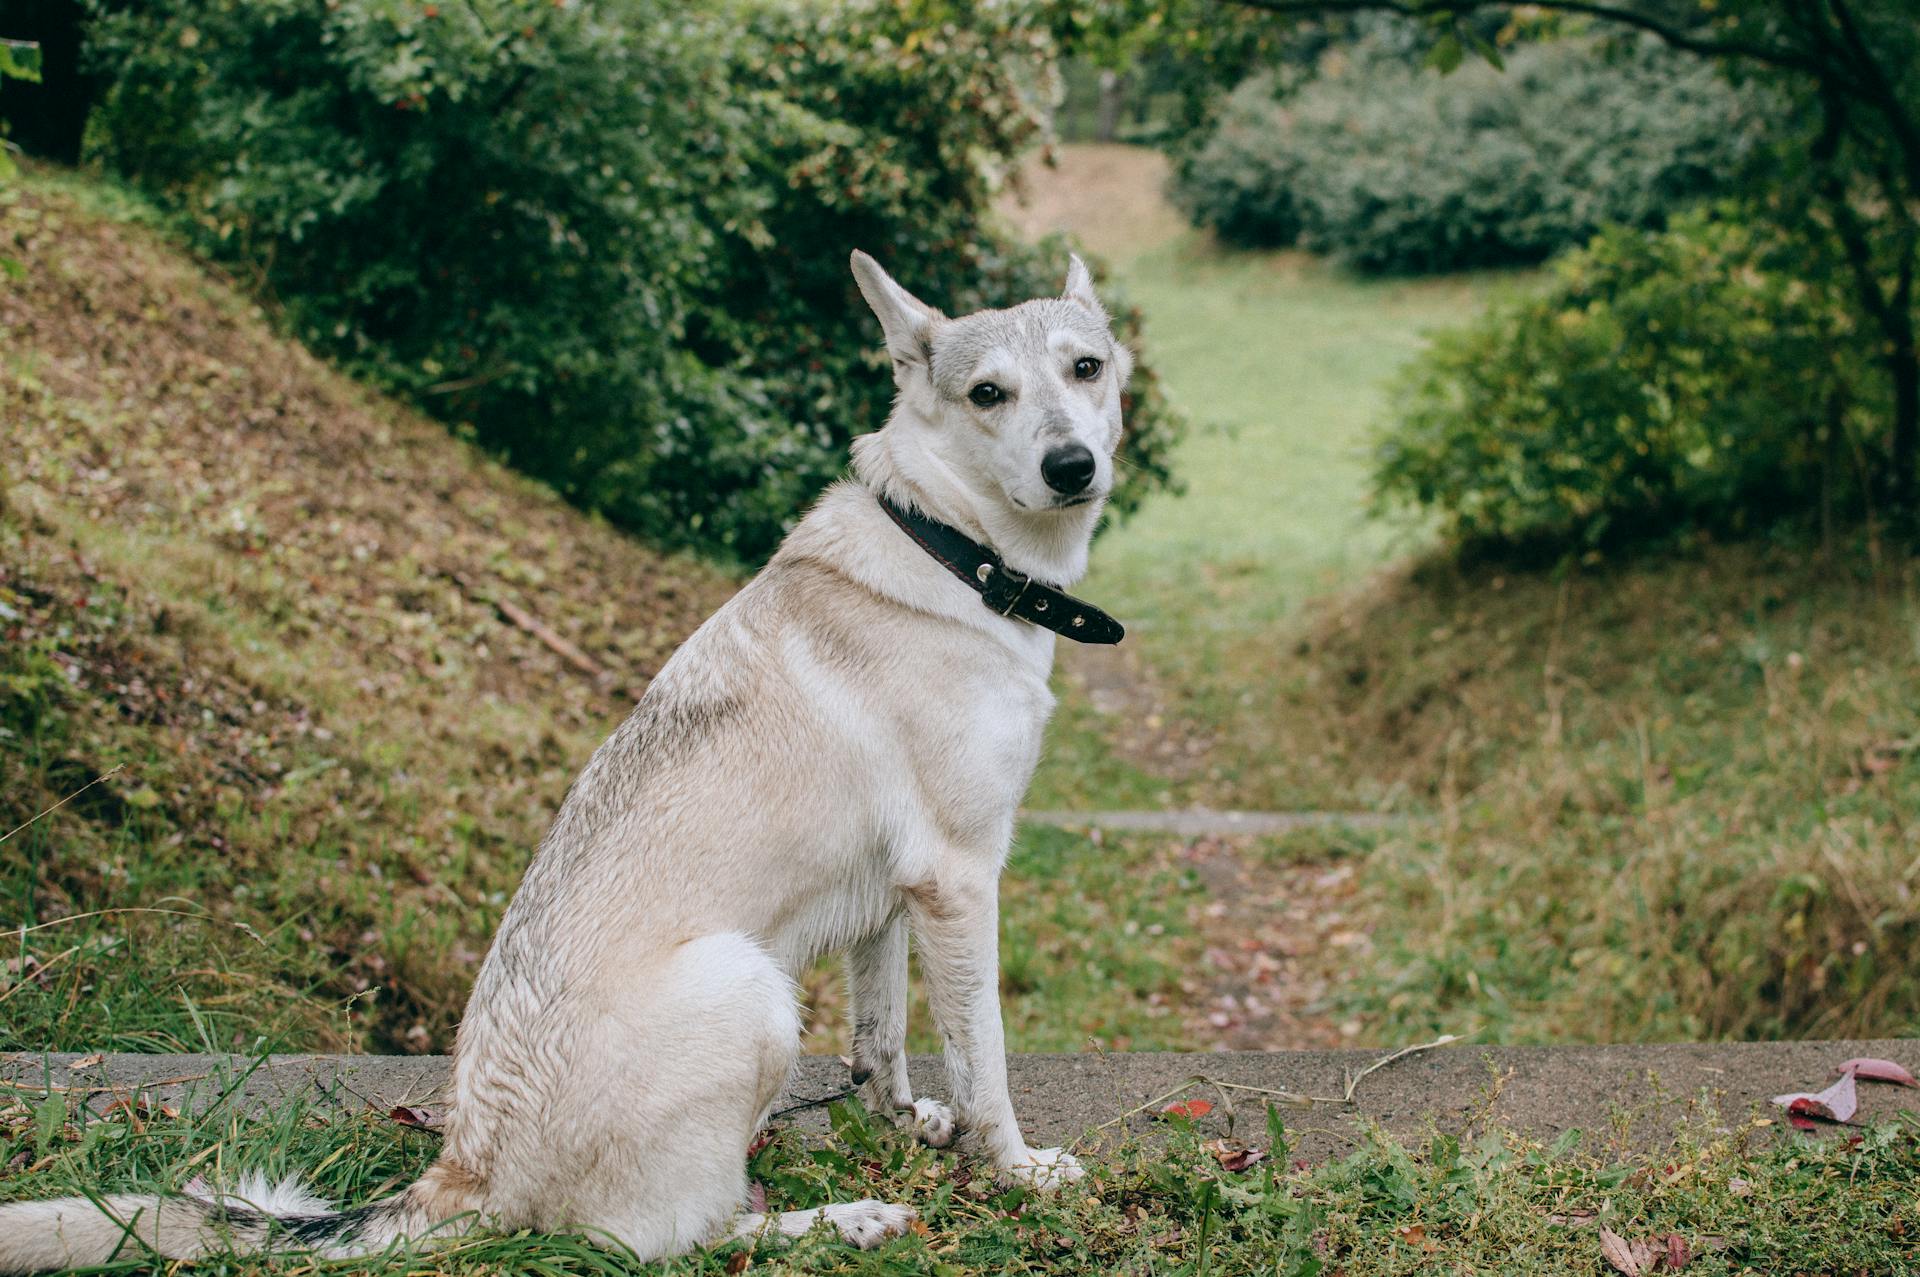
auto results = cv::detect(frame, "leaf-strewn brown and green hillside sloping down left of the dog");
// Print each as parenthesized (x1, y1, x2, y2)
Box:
(0, 177, 732, 1050)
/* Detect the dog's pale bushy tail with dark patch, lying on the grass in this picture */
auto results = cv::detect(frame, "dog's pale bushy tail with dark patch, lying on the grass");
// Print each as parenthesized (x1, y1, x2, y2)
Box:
(0, 1160, 482, 1273)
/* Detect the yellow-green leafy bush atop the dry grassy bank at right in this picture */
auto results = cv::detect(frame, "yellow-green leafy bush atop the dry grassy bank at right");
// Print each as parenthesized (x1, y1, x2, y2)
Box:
(1375, 209, 1887, 545)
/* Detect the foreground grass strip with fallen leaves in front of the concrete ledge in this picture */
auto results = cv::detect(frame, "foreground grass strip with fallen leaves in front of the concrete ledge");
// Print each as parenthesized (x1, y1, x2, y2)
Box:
(0, 1067, 1920, 1277)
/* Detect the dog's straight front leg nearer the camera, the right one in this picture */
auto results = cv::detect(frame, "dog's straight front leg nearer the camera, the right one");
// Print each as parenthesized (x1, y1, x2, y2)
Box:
(906, 862, 1085, 1189)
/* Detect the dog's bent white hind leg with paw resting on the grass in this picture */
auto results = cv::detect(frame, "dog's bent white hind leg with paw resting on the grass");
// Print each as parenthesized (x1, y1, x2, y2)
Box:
(553, 933, 914, 1260)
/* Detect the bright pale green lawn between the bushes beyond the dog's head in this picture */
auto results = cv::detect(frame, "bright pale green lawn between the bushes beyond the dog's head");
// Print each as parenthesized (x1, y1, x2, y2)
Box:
(1087, 234, 1530, 633)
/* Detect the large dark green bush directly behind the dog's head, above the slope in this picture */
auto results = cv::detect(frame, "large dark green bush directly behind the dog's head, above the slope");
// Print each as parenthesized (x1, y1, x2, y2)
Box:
(90, 0, 1171, 559)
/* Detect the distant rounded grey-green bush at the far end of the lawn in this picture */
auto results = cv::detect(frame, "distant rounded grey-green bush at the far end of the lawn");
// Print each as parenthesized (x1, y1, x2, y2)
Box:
(1175, 40, 1759, 273)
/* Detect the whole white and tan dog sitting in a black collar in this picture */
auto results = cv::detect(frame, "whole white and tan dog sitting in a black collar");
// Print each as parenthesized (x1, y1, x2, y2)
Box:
(0, 252, 1133, 1273)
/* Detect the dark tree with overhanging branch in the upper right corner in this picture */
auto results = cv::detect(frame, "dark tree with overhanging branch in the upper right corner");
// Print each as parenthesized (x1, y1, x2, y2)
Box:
(1238, 0, 1920, 530)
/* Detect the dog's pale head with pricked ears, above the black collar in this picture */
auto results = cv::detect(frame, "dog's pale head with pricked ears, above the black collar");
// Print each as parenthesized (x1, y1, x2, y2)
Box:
(852, 252, 1133, 517)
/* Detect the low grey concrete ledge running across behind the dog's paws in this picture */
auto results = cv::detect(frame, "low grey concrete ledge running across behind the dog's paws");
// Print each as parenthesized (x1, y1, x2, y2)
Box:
(0, 1039, 1920, 1158)
